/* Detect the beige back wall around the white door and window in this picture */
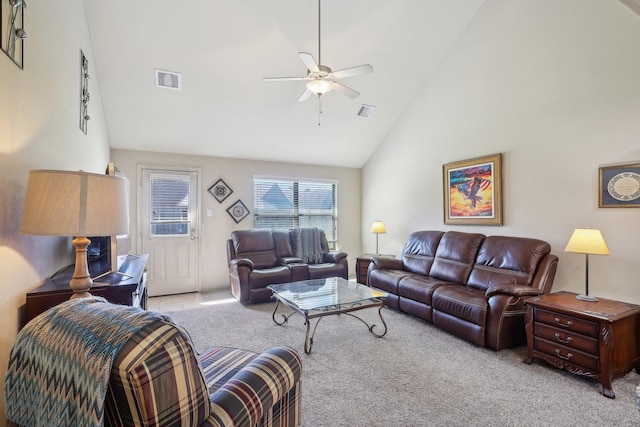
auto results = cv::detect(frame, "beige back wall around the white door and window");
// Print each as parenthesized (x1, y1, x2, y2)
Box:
(111, 149, 361, 290)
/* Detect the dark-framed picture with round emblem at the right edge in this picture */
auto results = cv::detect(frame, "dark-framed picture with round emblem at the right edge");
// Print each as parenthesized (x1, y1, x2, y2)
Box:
(598, 163, 640, 208)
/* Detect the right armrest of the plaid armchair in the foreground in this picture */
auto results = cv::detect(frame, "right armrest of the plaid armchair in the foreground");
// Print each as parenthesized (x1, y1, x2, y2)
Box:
(207, 347, 302, 426)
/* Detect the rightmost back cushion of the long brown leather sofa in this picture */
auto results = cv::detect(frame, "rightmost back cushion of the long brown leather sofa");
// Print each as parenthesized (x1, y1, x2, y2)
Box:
(467, 236, 551, 290)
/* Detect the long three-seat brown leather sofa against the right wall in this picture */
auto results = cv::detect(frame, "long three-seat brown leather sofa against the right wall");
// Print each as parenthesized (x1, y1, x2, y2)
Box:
(367, 231, 558, 350)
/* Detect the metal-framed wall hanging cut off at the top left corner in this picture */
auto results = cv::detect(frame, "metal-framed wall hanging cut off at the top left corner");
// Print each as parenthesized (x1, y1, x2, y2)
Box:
(0, 0, 27, 69)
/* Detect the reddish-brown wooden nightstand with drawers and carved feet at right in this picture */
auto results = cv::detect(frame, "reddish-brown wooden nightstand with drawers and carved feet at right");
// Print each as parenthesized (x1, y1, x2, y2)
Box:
(524, 292, 640, 399)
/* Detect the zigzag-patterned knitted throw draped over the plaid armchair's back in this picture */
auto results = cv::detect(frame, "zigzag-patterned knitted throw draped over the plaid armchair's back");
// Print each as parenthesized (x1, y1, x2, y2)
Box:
(5, 297, 171, 427)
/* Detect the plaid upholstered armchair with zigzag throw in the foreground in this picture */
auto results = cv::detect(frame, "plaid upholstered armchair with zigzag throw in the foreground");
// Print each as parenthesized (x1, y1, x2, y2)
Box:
(5, 297, 301, 426)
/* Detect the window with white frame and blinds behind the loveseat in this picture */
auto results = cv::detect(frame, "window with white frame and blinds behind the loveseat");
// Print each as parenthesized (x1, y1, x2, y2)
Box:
(253, 177, 338, 249)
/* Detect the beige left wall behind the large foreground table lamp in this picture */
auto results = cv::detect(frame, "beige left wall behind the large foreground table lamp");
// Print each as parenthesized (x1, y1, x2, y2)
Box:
(0, 0, 109, 425)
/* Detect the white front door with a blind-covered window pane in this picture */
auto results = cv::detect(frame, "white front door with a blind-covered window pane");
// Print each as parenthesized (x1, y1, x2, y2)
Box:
(139, 167, 200, 296)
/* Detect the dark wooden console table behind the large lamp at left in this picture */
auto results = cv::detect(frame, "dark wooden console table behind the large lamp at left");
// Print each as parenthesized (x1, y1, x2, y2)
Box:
(22, 254, 149, 325)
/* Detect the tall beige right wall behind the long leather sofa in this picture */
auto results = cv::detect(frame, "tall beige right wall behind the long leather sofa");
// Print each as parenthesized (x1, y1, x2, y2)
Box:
(362, 0, 640, 303)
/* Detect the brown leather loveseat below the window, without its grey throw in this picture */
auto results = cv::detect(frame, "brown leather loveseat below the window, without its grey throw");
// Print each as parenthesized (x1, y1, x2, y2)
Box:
(227, 228, 349, 304)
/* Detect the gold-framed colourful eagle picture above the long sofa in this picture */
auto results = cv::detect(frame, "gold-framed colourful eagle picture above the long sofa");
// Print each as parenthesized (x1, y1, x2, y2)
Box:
(442, 153, 502, 225)
